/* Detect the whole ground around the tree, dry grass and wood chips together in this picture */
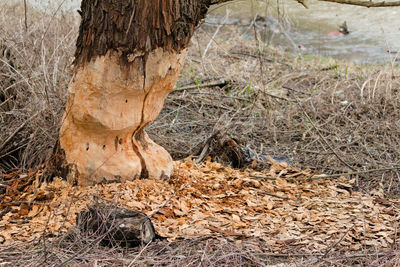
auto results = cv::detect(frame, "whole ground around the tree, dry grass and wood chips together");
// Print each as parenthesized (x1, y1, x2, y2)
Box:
(0, 2, 400, 266)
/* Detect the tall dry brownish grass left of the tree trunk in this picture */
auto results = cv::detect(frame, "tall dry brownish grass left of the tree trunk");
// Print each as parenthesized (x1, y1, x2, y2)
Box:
(0, 4, 78, 174)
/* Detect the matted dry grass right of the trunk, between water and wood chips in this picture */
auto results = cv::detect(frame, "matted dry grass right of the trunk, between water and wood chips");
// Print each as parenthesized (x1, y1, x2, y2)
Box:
(150, 16, 400, 195)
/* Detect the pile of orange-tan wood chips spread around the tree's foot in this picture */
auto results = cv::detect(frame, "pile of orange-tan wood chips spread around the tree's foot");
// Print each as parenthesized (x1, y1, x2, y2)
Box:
(0, 159, 400, 253)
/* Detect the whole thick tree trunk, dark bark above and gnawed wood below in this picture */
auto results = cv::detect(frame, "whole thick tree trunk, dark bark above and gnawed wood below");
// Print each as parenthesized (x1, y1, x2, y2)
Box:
(54, 0, 211, 184)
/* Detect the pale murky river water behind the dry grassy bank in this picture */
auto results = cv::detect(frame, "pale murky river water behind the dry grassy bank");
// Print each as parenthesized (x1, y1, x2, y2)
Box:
(0, 0, 400, 63)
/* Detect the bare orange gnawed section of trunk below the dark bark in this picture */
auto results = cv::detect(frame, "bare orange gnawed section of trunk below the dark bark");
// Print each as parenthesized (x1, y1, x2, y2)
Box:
(57, 49, 186, 185)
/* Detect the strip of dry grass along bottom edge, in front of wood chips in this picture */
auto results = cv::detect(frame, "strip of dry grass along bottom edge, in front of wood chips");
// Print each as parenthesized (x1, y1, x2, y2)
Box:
(0, 237, 400, 267)
